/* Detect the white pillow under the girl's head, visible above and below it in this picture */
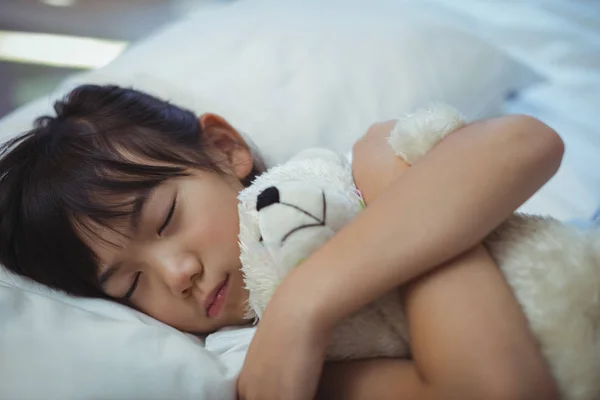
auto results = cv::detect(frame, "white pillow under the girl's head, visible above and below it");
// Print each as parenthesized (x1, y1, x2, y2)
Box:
(0, 0, 534, 400)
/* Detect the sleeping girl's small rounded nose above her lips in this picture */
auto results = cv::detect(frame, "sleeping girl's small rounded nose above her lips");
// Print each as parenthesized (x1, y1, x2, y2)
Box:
(159, 254, 203, 297)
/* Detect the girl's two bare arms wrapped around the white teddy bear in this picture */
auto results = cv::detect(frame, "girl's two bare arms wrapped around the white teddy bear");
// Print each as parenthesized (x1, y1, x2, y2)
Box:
(239, 116, 563, 400)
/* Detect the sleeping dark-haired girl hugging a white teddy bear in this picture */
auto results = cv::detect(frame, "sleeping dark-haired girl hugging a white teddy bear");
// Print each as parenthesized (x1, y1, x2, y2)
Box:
(0, 85, 563, 400)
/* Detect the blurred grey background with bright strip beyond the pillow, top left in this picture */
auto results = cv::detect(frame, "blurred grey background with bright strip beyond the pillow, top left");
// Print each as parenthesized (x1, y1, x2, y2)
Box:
(0, 0, 220, 118)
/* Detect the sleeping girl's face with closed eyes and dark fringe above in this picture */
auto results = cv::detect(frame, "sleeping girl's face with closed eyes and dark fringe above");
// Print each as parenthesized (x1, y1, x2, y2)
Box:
(82, 114, 252, 333)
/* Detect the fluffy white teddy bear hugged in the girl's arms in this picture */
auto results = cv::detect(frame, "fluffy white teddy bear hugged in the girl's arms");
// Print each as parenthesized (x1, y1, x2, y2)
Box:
(239, 105, 600, 400)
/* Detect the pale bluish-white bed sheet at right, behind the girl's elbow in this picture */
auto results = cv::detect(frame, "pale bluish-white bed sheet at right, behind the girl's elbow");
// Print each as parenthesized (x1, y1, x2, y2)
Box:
(432, 0, 600, 220)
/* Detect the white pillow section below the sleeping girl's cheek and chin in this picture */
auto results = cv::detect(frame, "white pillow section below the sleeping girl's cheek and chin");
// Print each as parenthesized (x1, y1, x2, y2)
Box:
(0, 268, 253, 400)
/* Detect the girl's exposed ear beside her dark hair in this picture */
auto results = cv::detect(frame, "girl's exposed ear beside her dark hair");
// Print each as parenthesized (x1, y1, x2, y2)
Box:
(199, 114, 253, 180)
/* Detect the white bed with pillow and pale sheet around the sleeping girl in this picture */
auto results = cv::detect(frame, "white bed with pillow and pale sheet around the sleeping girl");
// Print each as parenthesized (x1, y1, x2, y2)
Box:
(0, 0, 600, 400)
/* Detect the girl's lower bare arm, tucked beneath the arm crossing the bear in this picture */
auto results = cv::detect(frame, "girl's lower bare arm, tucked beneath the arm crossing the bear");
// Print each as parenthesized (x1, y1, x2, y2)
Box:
(317, 246, 557, 400)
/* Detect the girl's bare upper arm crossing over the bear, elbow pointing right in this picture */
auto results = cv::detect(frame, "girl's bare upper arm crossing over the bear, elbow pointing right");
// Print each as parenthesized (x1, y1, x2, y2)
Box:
(238, 116, 563, 400)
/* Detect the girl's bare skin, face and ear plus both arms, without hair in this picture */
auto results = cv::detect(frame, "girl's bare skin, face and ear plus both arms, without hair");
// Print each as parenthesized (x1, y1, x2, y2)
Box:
(49, 110, 563, 400)
